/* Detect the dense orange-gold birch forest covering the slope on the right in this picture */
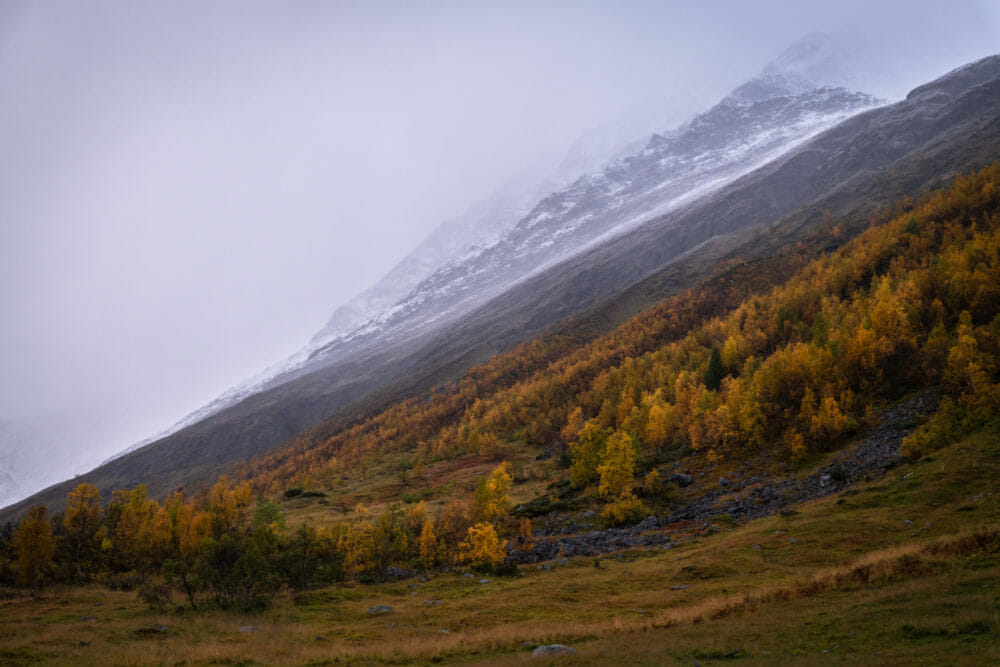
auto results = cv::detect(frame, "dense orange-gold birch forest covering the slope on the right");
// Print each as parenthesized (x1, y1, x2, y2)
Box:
(236, 166, 1000, 500)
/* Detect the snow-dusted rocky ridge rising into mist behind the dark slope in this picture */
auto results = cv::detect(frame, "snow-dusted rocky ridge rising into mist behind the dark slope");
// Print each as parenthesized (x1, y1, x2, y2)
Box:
(105, 36, 883, 458)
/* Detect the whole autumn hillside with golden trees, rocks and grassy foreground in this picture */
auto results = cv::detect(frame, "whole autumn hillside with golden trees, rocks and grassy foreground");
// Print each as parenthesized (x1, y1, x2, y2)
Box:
(0, 165, 1000, 664)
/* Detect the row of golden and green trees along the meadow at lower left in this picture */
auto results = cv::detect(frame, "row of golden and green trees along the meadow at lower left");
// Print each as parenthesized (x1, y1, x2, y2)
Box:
(0, 464, 511, 610)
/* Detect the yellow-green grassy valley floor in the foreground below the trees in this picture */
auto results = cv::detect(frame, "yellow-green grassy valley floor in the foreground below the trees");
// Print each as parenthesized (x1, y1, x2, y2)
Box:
(0, 431, 1000, 665)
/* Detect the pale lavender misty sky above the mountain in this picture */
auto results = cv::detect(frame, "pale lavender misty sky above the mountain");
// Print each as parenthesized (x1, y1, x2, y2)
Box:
(0, 0, 1000, 495)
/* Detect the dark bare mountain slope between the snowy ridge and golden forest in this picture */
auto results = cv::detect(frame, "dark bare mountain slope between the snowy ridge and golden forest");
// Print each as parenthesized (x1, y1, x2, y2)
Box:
(5, 57, 1000, 516)
